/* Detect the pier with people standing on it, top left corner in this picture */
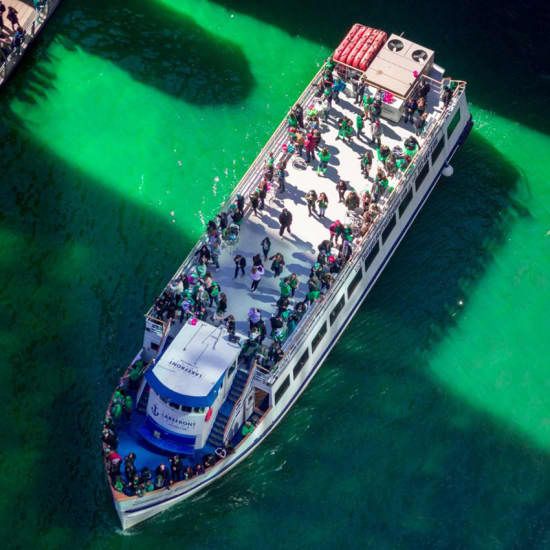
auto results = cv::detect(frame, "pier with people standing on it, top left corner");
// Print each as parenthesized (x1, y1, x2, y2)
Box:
(0, 0, 61, 86)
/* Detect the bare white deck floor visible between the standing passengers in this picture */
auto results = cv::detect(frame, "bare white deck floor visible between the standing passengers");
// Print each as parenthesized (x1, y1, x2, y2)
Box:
(168, 83, 439, 335)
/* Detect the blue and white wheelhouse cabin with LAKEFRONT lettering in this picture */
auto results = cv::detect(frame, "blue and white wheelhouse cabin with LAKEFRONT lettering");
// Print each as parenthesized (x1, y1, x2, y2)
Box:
(139, 319, 241, 455)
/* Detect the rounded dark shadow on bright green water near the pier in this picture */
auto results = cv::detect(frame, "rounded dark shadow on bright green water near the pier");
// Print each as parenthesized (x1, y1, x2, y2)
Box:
(10, 0, 254, 108)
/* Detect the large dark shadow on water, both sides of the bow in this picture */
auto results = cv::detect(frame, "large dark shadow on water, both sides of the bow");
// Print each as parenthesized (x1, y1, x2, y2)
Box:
(0, 68, 550, 549)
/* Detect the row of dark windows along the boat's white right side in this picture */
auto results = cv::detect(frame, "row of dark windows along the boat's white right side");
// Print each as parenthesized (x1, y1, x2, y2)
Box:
(275, 110, 468, 403)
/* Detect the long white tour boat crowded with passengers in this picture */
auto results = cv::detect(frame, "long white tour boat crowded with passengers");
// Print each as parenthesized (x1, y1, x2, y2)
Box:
(102, 24, 472, 529)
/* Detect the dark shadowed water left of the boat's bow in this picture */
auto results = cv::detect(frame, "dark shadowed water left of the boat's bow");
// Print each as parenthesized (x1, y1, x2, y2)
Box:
(0, 113, 199, 548)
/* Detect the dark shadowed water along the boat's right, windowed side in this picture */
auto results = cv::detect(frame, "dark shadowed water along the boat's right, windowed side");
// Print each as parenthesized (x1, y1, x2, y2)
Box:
(126, 134, 550, 550)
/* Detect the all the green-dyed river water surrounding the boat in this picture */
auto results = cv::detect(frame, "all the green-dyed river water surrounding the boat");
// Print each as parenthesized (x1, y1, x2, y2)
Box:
(0, 0, 550, 549)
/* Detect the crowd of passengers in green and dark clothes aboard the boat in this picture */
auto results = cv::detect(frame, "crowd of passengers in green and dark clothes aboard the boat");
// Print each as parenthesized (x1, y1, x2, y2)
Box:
(103, 59, 458, 496)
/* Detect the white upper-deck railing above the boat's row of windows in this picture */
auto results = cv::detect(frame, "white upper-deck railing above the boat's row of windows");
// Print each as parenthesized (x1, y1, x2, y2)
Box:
(267, 81, 466, 384)
